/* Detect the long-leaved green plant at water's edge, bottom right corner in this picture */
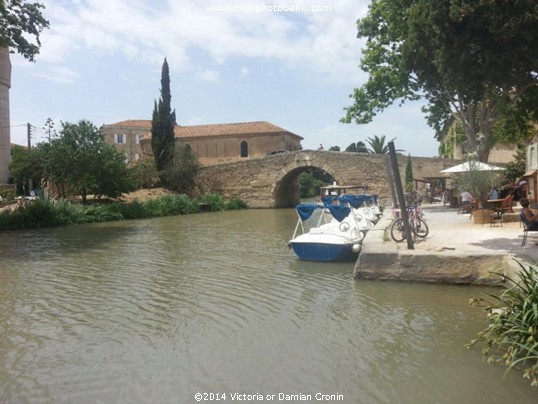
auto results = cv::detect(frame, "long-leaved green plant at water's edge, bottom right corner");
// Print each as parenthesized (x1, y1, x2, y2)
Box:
(468, 264, 538, 386)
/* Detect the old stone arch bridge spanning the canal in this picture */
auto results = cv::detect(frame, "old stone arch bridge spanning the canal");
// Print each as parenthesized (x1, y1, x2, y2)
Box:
(197, 150, 459, 208)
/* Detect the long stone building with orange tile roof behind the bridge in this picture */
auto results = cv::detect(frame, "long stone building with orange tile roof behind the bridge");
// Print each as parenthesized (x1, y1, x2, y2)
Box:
(101, 120, 303, 165)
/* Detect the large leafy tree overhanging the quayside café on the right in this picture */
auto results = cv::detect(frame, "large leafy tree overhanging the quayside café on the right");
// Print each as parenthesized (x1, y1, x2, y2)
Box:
(343, 0, 538, 161)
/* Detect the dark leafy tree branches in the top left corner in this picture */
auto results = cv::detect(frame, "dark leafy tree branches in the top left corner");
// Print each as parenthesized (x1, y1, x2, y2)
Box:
(0, 0, 49, 62)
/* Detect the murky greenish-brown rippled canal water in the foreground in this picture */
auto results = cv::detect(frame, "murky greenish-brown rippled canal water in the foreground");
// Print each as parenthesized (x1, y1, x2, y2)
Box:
(0, 209, 538, 404)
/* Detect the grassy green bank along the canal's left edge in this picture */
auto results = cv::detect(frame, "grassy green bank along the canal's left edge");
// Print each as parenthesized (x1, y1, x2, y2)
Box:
(0, 194, 246, 231)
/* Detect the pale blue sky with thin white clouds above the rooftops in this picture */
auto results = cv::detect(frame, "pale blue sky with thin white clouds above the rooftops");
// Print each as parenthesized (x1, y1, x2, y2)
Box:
(10, 0, 438, 157)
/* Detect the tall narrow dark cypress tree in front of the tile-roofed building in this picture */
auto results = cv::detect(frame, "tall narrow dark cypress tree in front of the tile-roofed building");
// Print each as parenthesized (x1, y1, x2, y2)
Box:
(151, 58, 176, 185)
